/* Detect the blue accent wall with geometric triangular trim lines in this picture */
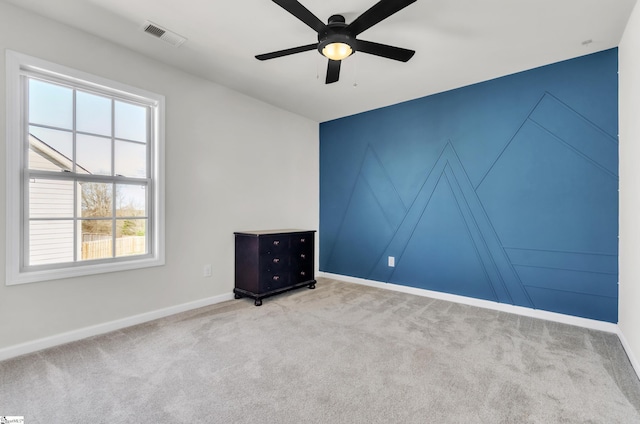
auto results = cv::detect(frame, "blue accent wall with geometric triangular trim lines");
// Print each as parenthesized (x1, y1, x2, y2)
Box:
(319, 49, 618, 322)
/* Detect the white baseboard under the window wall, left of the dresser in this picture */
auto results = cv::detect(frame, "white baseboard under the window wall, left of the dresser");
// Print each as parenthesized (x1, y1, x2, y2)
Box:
(0, 293, 233, 361)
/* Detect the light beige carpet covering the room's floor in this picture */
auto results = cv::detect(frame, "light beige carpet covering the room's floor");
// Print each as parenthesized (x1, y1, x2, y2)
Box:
(0, 279, 640, 424)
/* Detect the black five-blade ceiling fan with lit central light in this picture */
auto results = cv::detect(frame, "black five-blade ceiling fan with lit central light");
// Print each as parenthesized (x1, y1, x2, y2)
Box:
(256, 0, 416, 84)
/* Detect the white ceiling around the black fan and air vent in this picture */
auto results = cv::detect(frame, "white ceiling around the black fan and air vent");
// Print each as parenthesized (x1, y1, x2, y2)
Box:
(5, 0, 636, 122)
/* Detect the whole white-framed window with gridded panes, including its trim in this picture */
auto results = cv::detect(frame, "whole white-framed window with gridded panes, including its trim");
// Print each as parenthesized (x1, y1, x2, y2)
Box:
(6, 51, 164, 284)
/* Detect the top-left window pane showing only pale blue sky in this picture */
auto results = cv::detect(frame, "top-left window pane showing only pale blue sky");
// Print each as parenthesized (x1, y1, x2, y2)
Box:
(29, 79, 73, 130)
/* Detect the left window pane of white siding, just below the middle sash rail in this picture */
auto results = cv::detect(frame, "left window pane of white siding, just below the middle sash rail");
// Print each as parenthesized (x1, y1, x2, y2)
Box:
(29, 178, 74, 218)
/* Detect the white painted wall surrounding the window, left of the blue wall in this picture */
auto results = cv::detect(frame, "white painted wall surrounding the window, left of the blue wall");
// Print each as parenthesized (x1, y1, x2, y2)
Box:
(0, 1, 319, 350)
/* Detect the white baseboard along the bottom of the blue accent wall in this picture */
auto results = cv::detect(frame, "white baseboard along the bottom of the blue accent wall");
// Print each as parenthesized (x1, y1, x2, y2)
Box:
(318, 272, 620, 334)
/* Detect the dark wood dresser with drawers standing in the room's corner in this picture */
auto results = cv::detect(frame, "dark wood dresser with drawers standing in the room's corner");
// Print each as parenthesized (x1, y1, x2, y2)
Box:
(233, 230, 316, 306)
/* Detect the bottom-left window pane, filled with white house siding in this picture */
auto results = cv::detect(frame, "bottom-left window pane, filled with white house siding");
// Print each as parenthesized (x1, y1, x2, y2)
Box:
(28, 220, 73, 265)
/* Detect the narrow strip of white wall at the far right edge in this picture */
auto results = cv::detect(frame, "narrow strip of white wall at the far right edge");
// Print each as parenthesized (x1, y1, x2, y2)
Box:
(618, 0, 640, 373)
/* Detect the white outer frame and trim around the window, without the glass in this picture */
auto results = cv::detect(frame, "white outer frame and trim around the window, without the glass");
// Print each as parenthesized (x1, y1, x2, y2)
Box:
(6, 50, 165, 285)
